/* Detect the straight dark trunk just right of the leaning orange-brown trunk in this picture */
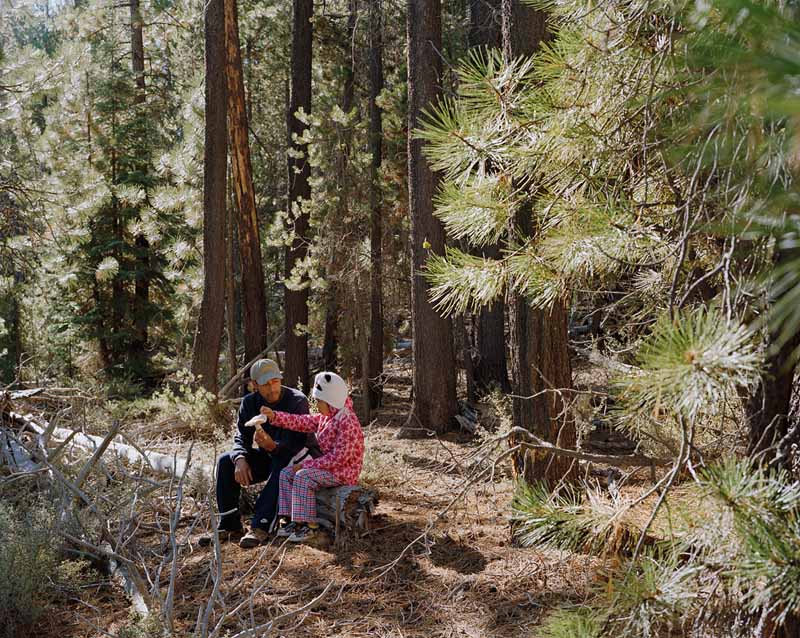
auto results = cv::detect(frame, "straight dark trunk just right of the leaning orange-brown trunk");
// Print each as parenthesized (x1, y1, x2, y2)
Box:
(284, 0, 314, 391)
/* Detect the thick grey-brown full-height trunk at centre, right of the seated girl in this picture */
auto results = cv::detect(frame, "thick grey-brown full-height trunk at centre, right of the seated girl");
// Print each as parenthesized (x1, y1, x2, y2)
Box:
(407, 0, 458, 433)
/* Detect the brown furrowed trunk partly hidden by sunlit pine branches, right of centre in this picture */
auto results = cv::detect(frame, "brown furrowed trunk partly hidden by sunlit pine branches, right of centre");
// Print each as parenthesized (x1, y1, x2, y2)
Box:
(502, 0, 577, 486)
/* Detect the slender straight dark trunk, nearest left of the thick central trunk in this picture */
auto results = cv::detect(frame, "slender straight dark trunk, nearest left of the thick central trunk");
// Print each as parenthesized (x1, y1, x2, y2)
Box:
(367, 0, 383, 407)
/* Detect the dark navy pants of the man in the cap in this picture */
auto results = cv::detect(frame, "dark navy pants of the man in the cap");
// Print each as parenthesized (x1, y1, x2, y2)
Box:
(217, 450, 293, 531)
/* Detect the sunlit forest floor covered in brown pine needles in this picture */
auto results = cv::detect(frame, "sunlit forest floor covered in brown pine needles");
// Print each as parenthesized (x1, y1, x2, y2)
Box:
(26, 360, 636, 638)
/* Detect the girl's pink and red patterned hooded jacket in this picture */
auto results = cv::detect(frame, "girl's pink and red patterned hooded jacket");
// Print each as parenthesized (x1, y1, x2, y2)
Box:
(270, 397, 364, 485)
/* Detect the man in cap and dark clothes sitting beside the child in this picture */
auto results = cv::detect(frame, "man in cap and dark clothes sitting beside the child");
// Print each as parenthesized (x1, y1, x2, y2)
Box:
(200, 359, 316, 547)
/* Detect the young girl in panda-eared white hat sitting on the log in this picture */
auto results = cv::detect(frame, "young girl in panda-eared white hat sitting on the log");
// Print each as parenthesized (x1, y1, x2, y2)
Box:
(261, 372, 364, 543)
